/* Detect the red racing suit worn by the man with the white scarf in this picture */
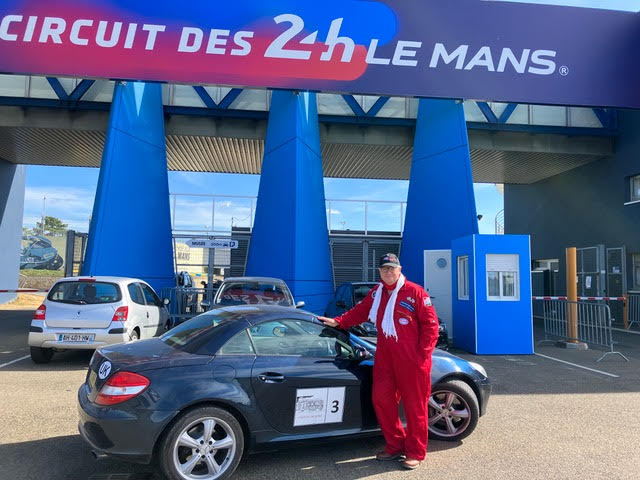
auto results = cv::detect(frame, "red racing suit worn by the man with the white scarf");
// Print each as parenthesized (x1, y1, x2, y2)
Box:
(335, 280, 438, 460)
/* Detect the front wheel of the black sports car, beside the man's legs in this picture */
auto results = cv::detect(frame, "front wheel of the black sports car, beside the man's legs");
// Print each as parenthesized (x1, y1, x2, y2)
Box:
(428, 380, 480, 442)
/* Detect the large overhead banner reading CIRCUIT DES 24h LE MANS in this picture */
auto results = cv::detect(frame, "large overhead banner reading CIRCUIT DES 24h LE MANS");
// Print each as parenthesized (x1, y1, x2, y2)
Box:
(0, 0, 640, 108)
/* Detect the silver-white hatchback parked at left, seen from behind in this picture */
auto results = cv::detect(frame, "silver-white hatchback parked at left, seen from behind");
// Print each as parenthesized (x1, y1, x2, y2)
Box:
(29, 276, 169, 363)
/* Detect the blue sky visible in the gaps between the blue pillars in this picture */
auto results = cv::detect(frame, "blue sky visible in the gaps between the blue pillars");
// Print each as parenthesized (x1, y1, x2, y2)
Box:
(23, 165, 503, 233)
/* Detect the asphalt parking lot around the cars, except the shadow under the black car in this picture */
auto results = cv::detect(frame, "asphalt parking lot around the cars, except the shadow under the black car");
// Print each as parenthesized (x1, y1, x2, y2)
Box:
(0, 310, 640, 480)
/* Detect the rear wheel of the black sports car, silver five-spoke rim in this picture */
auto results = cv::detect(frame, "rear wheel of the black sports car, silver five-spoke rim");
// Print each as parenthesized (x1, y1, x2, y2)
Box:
(158, 407, 244, 480)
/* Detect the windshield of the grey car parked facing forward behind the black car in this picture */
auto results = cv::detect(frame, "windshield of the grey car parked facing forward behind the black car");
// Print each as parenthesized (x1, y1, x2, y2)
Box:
(216, 282, 293, 306)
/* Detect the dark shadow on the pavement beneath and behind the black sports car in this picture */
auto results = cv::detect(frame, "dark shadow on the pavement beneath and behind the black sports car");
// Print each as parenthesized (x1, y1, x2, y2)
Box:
(0, 435, 461, 480)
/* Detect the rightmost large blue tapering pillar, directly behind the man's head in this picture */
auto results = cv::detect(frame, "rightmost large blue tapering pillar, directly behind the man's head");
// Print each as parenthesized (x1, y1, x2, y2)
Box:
(400, 99, 478, 284)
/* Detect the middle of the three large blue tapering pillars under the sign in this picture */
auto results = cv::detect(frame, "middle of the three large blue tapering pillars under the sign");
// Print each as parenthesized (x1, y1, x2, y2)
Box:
(246, 91, 333, 313)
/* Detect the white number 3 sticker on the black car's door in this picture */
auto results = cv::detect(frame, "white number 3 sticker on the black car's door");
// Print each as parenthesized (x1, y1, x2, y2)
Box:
(293, 387, 344, 427)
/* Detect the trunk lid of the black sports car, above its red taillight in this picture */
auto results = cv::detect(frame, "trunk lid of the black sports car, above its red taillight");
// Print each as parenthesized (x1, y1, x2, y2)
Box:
(98, 338, 212, 372)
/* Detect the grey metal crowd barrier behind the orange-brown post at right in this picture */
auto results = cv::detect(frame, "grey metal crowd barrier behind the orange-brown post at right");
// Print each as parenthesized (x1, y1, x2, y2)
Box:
(542, 299, 629, 362)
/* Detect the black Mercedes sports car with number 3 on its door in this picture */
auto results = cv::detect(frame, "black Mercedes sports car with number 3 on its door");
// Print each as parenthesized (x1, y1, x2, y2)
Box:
(78, 306, 491, 480)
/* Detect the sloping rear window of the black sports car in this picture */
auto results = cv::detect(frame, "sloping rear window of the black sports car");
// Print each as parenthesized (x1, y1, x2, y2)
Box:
(160, 308, 246, 349)
